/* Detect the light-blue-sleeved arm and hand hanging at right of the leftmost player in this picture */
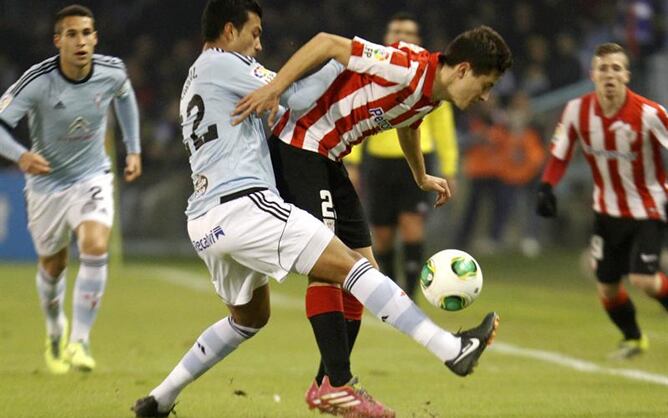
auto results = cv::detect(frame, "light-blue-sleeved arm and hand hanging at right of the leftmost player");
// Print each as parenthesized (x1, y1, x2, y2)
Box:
(114, 79, 142, 182)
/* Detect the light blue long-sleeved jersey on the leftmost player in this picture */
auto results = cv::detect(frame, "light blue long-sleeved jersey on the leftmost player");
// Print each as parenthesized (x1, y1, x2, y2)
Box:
(0, 54, 140, 193)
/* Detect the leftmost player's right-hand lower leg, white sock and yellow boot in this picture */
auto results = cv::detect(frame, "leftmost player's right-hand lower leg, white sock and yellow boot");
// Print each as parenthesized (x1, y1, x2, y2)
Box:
(65, 253, 109, 372)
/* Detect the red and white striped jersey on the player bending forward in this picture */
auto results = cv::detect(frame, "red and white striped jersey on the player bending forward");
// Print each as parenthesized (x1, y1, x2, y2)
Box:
(273, 37, 440, 161)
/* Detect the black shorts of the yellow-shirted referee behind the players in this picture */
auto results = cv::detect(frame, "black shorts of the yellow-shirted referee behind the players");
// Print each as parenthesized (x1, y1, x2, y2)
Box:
(364, 154, 435, 226)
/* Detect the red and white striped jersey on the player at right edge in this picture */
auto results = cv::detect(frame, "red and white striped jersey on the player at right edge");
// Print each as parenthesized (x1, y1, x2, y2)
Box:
(551, 89, 668, 219)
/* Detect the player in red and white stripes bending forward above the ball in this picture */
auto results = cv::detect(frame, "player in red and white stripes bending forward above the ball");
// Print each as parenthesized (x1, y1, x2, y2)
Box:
(235, 26, 512, 414)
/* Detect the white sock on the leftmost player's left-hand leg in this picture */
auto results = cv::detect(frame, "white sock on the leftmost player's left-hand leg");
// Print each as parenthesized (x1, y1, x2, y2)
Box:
(35, 266, 66, 337)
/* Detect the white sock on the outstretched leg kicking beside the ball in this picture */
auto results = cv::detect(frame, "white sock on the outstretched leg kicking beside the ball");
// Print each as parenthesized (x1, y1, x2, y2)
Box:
(343, 258, 461, 362)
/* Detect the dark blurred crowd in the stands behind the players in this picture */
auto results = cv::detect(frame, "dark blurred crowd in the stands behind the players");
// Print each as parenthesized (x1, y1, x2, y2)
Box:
(0, 0, 668, 256)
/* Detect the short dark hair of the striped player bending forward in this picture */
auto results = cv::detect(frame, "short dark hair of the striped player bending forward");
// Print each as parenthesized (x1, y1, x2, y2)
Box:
(440, 26, 513, 75)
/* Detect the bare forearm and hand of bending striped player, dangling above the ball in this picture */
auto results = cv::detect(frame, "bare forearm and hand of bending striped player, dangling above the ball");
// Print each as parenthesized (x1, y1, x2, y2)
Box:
(397, 127, 452, 207)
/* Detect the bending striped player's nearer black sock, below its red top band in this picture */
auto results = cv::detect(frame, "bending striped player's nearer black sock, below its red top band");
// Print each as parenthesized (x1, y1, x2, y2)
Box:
(309, 312, 353, 386)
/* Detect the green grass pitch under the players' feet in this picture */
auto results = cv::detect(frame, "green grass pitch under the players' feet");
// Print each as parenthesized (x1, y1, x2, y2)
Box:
(0, 253, 668, 418)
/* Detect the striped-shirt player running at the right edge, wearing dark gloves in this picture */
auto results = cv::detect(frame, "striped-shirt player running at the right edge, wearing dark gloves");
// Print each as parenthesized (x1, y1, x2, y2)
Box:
(537, 43, 668, 358)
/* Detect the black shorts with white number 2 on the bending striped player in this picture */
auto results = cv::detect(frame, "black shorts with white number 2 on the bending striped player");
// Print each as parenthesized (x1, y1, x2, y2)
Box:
(269, 136, 371, 248)
